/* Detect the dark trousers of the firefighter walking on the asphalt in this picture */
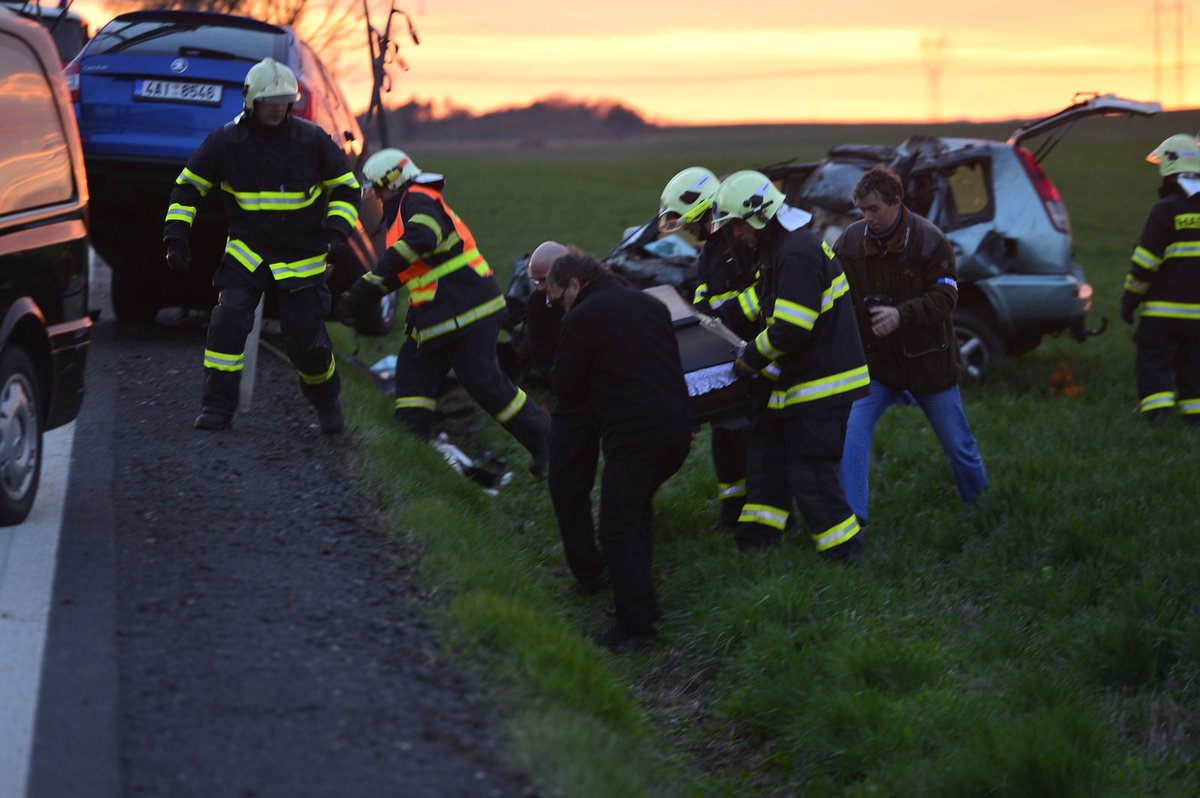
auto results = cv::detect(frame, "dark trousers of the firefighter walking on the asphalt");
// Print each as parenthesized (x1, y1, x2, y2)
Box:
(203, 258, 341, 416)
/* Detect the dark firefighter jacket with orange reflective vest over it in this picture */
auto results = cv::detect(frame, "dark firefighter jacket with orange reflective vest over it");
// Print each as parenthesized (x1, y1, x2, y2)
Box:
(362, 182, 505, 347)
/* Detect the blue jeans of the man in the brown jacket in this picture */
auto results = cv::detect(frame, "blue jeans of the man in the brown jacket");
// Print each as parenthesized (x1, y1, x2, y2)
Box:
(841, 380, 988, 522)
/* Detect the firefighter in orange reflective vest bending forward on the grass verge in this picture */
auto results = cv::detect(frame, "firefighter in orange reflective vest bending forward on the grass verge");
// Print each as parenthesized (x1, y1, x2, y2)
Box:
(338, 148, 550, 474)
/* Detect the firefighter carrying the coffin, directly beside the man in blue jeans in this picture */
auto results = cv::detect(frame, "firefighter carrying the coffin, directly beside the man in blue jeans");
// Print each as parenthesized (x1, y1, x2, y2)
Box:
(712, 170, 870, 562)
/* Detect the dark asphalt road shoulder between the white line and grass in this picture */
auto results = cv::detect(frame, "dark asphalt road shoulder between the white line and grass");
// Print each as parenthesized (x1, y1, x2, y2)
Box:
(9, 258, 535, 798)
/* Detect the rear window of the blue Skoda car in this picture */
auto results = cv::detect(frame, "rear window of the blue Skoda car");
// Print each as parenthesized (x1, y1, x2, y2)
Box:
(88, 19, 287, 61)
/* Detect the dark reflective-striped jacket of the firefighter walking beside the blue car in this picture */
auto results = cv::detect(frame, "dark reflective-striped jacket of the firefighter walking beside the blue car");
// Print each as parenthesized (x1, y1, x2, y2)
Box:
(163, 114, 360, 288)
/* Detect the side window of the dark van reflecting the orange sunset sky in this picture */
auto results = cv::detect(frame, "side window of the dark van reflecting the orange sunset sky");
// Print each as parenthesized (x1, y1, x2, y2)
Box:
(0, 34, 74, 216)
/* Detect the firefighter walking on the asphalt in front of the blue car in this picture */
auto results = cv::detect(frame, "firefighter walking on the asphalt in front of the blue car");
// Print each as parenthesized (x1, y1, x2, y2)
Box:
(163, 58, 360, 434)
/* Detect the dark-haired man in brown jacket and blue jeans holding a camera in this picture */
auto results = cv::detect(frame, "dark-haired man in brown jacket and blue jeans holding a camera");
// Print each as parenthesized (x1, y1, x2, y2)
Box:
(834, 166, 988, 524)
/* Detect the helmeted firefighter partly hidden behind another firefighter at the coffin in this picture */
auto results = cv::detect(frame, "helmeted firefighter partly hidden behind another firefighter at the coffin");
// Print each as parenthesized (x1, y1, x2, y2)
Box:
(658, 167, 758, 532)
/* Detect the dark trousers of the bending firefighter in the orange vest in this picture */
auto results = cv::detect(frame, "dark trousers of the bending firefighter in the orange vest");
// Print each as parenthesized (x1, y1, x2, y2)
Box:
(396, 313, 550, 458)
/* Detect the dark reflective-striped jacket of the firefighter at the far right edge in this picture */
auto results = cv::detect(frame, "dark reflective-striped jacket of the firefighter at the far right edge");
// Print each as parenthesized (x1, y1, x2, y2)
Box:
(1124, 192, 1200, 335)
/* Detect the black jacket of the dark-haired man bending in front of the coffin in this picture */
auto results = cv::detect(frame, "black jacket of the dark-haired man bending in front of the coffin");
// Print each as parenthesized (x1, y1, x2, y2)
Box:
(550, 276, 691, 448)
